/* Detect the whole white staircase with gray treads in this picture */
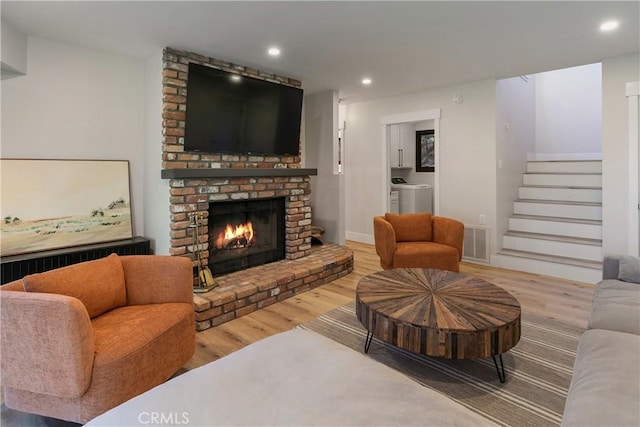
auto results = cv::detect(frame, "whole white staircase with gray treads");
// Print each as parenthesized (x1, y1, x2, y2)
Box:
(496, 160, 602, 283)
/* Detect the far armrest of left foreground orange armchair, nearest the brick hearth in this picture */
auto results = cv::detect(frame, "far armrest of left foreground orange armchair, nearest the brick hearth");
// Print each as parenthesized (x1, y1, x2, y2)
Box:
(120, 255, 193, 305)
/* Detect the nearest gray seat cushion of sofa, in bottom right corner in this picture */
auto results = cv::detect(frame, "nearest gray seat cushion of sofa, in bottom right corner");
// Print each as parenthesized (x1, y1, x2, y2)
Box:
(562, 329, 640, 427)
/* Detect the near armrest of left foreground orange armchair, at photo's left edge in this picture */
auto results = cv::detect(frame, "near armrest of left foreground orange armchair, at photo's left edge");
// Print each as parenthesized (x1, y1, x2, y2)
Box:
(0, 290, 94, 398)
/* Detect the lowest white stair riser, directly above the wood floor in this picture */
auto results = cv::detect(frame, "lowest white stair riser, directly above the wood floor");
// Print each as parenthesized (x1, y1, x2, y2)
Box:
(492, 255, 602, 284)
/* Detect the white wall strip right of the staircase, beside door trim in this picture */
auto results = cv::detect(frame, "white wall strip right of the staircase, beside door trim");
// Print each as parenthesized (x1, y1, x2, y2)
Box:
(602, 54, 640, 254)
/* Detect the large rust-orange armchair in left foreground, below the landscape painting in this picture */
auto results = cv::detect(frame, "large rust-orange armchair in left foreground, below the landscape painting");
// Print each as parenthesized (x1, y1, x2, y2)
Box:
(0, 254, 195, 423)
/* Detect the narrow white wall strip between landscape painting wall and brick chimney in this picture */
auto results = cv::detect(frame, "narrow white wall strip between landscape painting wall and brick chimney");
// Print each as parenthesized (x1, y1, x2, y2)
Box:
(143, 49, 171, 255)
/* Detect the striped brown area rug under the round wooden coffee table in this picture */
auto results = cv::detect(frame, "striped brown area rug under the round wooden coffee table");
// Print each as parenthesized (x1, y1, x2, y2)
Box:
(300, 303, 584, 427)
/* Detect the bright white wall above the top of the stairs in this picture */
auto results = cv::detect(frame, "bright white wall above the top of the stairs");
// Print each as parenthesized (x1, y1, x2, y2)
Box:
(535, 63, 602, 153)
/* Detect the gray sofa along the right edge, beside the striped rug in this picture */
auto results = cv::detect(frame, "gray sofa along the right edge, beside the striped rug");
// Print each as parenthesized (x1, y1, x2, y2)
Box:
(562, 255, 640, 427)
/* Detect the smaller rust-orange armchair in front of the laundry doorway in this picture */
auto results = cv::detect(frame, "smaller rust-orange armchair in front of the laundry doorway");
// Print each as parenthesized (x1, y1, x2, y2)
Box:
(373, 213, 464, 272)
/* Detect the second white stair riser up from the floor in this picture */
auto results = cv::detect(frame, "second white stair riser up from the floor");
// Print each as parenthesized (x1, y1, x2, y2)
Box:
(502, 236, 602, 261)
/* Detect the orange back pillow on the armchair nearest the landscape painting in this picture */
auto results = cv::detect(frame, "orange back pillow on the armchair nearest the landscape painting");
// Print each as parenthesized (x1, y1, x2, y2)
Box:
(22, 254, 127, 319)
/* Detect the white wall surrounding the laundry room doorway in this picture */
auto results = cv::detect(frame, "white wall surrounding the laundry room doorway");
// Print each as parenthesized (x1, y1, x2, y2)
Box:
(345, 80, 496, 241)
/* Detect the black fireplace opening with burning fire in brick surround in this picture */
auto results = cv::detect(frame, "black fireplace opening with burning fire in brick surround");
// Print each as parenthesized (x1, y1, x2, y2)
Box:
(209, 197, 285, 276)
